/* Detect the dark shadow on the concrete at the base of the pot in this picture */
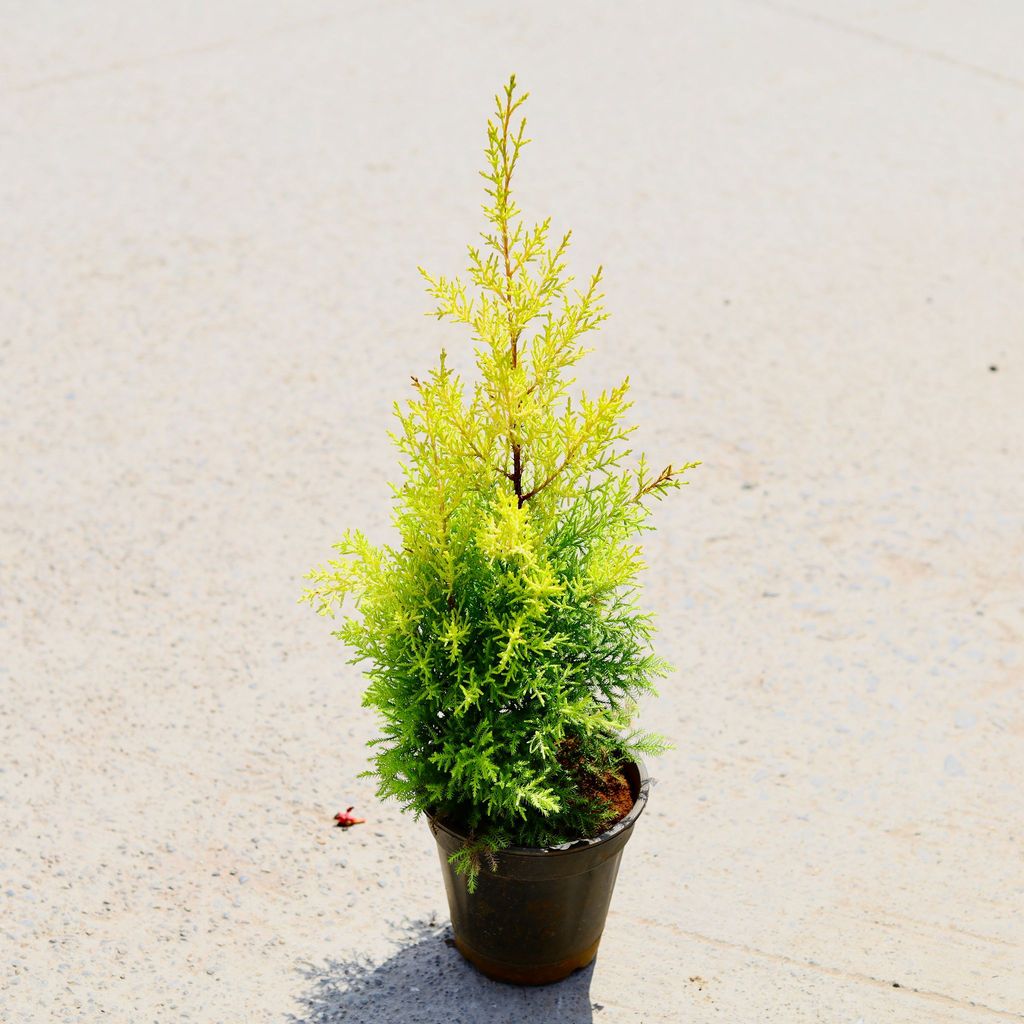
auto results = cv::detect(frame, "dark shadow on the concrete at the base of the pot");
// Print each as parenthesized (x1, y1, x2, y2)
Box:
(287, 923, 594, 1024)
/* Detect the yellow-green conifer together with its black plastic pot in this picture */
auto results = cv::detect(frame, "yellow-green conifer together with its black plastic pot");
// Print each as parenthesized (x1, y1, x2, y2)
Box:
(304, 76, 697, 984)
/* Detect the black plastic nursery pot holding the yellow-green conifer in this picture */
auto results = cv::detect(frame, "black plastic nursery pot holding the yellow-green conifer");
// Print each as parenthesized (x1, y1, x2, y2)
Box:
(430, 761, 650, 985)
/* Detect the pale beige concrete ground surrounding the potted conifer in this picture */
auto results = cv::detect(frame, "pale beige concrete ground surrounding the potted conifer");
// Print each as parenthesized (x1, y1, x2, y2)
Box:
(0, 0, 1024, 1024)
